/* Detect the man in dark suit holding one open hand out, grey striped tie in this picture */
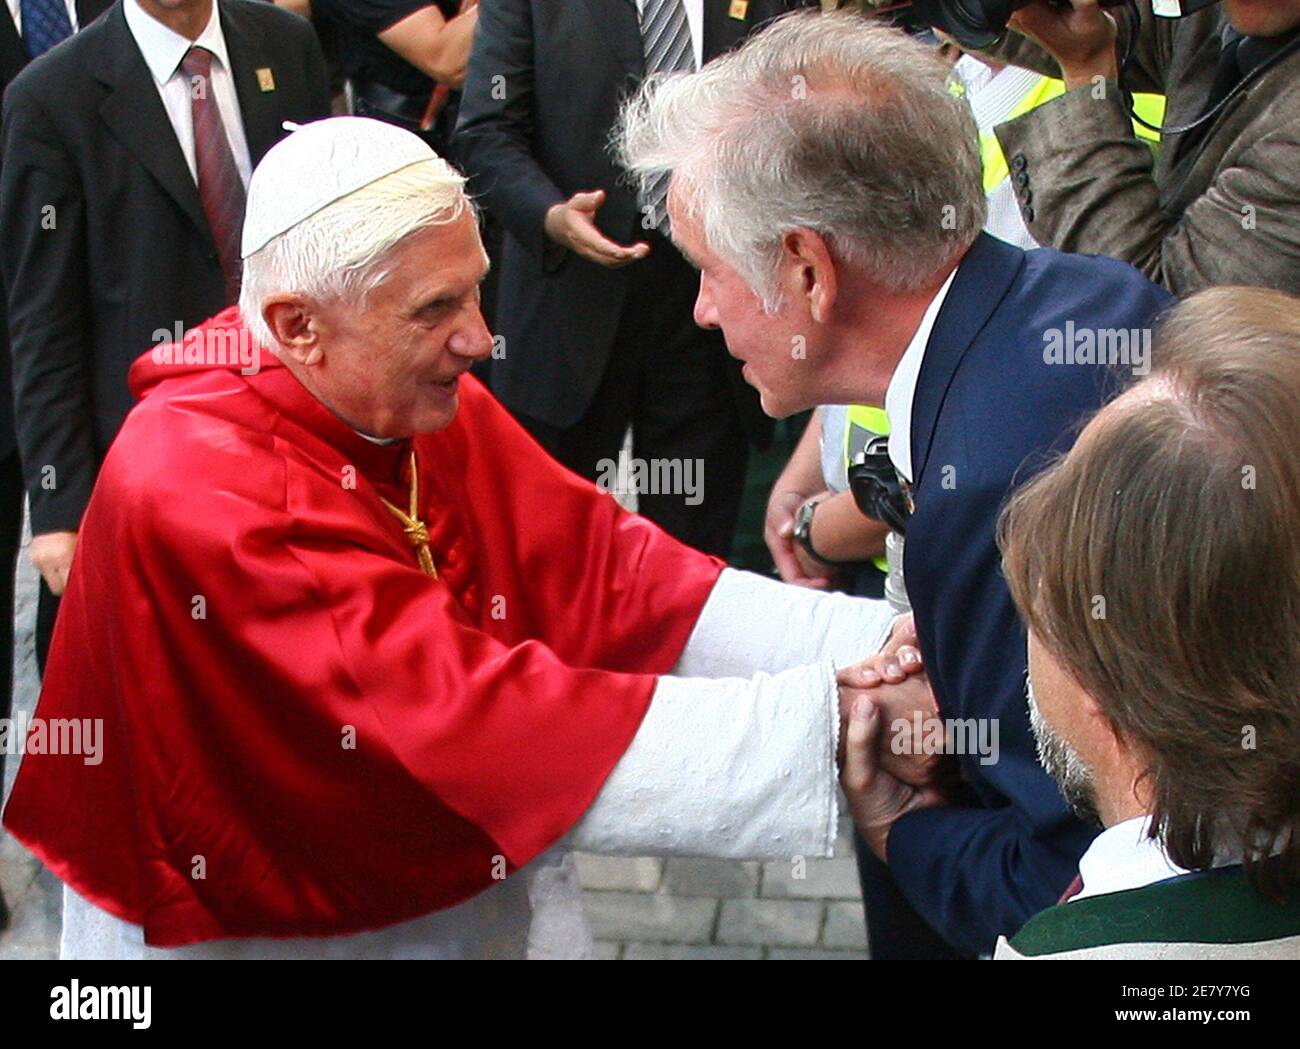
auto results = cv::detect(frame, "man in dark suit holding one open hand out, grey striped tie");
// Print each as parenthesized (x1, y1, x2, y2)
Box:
(455, 0, 802, 555)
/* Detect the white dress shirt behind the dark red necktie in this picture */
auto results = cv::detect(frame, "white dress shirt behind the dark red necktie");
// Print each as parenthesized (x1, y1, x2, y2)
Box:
(122, 0, 252, 188)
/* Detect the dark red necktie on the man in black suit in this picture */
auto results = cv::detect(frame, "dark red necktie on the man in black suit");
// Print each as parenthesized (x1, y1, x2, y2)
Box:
(181, 47, 244, 305)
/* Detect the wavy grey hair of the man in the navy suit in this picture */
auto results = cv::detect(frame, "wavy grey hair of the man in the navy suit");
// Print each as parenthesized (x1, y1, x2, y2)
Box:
(612, 12, 987, 311)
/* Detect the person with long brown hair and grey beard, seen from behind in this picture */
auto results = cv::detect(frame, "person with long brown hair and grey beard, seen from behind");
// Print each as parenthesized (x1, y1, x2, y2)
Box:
(987, 287, 1300, 959)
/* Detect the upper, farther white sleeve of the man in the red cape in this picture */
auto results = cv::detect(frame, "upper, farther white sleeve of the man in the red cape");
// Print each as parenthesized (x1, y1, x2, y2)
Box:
(672, 568, 894, 677)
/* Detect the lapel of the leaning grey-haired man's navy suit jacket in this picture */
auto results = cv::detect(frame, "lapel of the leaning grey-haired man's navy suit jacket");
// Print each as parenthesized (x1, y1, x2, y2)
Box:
(911, 233, 1024, 487)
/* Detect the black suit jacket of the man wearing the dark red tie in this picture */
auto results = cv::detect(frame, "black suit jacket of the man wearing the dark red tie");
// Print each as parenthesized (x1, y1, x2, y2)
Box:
(0, 0, 329, 533)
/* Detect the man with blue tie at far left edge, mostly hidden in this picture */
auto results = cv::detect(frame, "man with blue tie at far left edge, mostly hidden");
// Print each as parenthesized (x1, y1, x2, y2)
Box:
(0, 0, 112, 928)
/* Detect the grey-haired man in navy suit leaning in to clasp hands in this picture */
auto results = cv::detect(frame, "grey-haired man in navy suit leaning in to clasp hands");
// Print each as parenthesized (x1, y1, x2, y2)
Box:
(620, 16, 1169, 955)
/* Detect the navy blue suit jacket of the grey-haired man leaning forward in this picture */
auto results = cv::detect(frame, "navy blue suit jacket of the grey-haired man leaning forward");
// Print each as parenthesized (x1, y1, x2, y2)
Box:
(889, 234, 1170, 953)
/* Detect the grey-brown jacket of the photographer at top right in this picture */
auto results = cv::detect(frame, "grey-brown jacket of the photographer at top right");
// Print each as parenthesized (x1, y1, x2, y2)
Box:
(997, 0, 1300, 298)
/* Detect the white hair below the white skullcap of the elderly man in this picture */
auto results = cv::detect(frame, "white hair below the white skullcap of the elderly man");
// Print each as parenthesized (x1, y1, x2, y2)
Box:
(239, 157, 473, 352)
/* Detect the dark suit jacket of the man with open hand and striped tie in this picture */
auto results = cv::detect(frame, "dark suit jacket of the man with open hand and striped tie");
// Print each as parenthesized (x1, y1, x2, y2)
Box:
(456, 0, 803, 428)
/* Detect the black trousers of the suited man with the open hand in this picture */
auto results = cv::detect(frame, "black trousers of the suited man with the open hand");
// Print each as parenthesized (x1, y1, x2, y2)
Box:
(516, 234, 749, 558)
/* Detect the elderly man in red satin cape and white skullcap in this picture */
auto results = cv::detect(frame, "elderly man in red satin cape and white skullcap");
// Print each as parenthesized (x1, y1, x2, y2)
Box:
(5, 117, 925, 958)
